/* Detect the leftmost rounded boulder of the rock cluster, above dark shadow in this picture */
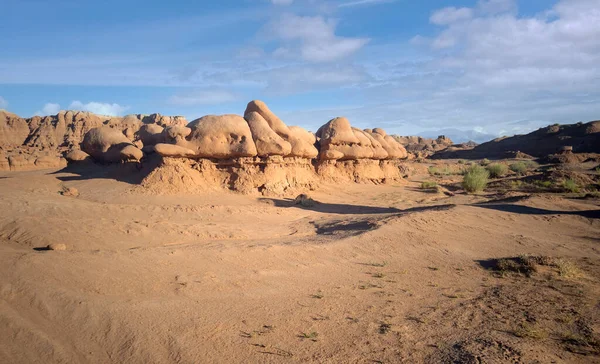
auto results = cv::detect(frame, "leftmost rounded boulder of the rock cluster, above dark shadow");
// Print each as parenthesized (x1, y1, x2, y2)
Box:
(81, 127, 143, 162)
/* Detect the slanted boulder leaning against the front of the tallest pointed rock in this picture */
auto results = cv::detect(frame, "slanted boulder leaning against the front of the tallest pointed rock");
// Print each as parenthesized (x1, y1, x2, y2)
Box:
(244, 111, 292, 157)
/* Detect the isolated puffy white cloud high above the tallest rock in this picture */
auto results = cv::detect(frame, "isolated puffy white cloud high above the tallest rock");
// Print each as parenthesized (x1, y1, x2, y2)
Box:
(269, 14, 369, 62)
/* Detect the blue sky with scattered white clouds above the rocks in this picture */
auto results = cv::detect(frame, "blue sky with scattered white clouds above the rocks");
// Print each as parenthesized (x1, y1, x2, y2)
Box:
(0, 0, 600, 142)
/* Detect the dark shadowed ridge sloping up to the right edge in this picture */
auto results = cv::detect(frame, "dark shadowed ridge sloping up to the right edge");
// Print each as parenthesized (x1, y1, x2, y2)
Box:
(432, 121, 600, 159)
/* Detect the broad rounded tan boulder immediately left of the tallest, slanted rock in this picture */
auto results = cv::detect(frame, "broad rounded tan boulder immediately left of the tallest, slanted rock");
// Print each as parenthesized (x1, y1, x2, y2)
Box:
(185, 115, 257, 159)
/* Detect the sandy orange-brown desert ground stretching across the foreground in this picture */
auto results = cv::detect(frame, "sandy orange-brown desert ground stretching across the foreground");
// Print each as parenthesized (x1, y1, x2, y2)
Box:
(0, 166, 600, 363)
